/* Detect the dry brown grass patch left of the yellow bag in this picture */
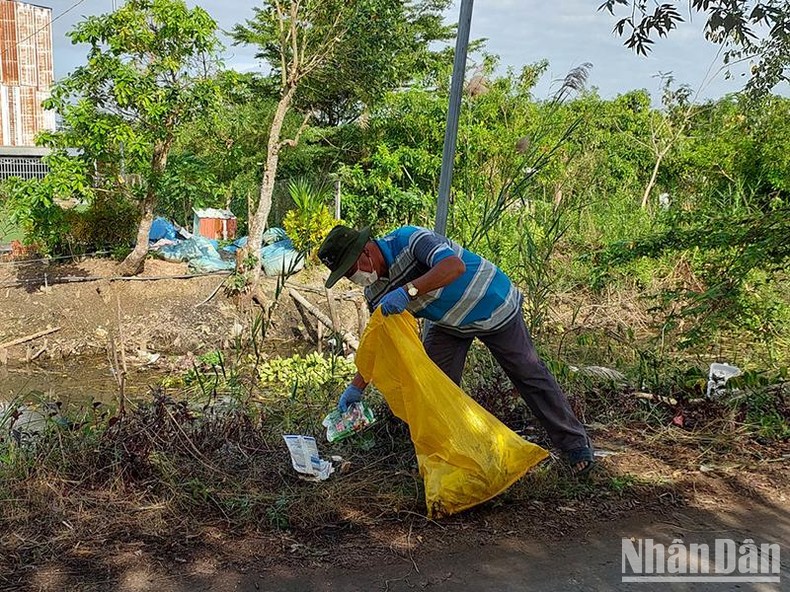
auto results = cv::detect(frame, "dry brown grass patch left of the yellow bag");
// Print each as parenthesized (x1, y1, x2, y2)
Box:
(0, 394, 422, 582)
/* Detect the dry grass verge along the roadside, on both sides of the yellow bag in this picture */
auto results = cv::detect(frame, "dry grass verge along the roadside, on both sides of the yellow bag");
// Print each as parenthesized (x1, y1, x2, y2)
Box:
(0, 386, 786, 586)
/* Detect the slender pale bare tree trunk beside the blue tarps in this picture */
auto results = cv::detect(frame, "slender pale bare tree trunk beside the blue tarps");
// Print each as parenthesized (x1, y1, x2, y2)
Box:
(237, 84, 296, 290)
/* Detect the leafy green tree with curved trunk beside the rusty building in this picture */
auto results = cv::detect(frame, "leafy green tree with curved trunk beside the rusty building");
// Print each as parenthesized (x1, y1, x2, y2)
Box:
(42, 0, 219, 275)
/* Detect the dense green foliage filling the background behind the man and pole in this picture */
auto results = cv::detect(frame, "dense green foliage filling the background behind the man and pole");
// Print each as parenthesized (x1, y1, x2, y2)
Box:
(2, 0, 790, 380)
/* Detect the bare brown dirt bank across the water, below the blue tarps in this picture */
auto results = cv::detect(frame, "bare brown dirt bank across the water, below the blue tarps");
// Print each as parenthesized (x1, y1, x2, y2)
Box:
(0, 259, 356, 367)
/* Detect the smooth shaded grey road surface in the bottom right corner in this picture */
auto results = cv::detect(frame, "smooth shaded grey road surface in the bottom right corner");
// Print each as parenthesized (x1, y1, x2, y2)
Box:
(230, 504, 790, 592)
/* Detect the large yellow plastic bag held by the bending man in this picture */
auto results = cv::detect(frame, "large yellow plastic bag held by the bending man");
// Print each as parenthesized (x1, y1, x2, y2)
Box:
(356, 310, 548, 518)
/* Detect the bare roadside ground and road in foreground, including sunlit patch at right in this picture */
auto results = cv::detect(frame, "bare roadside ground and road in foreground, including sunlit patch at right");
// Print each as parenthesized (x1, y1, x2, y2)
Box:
(13, 429, 790, 592)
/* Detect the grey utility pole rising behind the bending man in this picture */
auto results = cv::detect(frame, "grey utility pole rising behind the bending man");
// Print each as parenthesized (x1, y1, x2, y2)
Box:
(435, 0, 473, 234)
